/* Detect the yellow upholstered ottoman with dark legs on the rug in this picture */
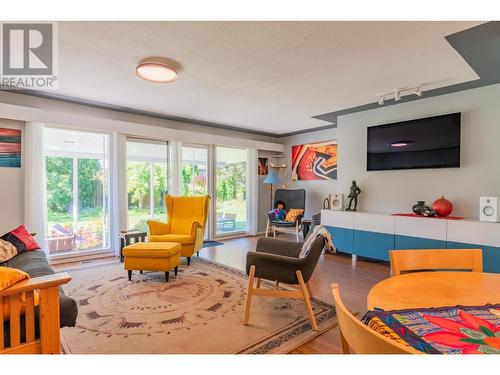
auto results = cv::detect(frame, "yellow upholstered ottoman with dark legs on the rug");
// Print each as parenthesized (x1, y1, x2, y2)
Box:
(123, 242, 181, 282)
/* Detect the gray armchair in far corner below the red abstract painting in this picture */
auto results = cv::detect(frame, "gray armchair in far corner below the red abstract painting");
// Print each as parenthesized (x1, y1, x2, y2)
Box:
(266, 189, 306, 242)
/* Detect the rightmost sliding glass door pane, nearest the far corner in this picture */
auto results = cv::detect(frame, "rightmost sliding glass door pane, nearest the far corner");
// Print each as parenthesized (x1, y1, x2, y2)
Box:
(215, 146, 248, 236)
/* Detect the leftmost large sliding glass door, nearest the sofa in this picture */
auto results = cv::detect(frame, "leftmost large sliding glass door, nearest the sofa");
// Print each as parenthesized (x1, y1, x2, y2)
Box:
(44, 127, 110, 255)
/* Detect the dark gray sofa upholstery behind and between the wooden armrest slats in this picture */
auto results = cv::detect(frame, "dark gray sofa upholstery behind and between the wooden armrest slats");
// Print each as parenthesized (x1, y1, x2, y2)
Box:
(0, 250, 78, 347)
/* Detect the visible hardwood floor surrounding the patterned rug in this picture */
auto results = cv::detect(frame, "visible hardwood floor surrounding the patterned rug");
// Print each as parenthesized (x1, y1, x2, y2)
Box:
(54, 235, 390, 354)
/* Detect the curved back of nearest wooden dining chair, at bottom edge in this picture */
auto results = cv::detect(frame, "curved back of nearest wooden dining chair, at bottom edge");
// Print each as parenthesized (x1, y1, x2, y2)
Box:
(331, 283, 422, 354)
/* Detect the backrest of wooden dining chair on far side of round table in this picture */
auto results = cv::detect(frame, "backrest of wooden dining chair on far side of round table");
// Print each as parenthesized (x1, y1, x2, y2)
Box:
(389, 249, 483, 276)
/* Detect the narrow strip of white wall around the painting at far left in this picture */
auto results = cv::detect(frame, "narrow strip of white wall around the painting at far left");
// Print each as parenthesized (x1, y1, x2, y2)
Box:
(0, 119, 24, 236)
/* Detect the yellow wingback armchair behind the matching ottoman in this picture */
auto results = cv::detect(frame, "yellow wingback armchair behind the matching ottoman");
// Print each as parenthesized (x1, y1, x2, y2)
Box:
(148, 195, 210, 265)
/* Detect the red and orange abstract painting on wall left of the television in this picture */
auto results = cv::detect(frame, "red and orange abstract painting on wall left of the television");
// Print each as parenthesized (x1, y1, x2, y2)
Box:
(292, 141, 337, 181)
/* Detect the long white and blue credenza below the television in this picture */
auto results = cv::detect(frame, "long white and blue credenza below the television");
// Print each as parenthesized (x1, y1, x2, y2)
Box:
(321, 210, 500, 273)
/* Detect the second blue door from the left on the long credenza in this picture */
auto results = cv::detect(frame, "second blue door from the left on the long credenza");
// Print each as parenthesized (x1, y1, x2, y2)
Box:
(354, 230, 394, 261)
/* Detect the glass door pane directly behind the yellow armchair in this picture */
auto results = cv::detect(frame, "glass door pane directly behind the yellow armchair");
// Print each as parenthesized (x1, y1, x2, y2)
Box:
(127, 138, 168, 231)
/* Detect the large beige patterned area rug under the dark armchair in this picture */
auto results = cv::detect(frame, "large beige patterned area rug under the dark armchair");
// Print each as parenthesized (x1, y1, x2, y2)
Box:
(61, 258, 337, 354)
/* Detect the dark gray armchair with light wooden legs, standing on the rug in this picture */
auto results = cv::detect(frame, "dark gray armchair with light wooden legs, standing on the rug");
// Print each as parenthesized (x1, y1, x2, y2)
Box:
(243, 236, 325, 331)
